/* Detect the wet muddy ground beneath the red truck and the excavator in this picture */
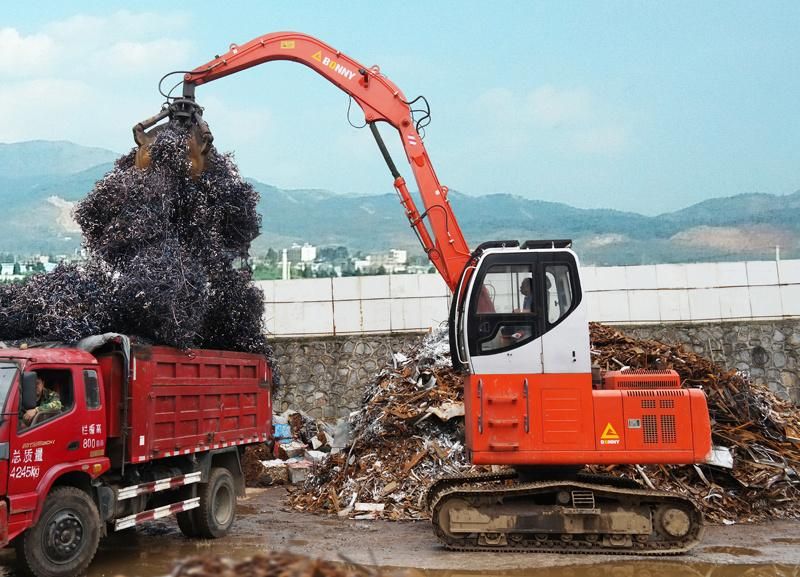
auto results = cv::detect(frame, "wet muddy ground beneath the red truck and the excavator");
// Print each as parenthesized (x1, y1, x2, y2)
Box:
(0, 487, 800, 577)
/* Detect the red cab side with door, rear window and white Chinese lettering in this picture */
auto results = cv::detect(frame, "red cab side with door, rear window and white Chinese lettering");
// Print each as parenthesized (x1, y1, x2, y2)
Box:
(8, 365, 105, 496)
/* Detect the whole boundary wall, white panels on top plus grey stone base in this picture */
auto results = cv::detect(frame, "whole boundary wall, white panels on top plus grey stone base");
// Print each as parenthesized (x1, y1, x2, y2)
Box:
(266, 260, 800, 420)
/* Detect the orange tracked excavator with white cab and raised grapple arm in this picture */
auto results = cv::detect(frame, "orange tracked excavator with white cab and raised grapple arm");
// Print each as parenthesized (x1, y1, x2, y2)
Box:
(134, 32, 711, 555)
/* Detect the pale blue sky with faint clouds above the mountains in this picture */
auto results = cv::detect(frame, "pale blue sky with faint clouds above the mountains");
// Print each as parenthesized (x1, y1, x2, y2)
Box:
(0, 0, 800, 214)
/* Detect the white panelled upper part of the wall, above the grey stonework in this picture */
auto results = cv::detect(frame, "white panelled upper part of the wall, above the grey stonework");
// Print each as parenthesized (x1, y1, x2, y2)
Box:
(258, 260, 800, 337)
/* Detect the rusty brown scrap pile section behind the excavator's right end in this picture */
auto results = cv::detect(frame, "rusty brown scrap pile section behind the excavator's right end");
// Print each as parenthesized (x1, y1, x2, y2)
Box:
(591, 324, 800, 523)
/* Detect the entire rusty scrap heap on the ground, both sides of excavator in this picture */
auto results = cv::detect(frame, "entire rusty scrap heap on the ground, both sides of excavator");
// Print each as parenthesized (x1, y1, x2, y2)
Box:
(289, 324, 800, 523)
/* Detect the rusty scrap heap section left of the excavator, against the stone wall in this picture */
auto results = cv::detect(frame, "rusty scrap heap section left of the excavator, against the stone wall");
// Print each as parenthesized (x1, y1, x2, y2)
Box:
(290, 331, 483, 520)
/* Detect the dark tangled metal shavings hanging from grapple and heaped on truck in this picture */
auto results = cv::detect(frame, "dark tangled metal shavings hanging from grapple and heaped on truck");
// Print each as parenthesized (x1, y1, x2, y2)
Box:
(0, 124, 272, 358)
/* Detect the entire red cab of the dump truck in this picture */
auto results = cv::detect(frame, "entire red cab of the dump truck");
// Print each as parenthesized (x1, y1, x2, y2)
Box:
(0, 348, 110, 544)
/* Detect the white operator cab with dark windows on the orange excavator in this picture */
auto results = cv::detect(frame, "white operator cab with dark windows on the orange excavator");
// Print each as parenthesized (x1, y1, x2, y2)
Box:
(451, 240, 590, 374)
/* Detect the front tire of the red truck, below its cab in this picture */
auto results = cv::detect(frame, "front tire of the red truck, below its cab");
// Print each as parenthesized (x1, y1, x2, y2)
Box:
(17, 487, 100, 577)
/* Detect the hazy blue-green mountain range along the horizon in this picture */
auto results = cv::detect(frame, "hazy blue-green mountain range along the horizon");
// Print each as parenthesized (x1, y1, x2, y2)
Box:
(0, 141, 800, 265)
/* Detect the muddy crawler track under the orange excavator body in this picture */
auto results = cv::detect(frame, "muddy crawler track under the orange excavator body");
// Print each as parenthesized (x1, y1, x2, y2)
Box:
(428, 472, 704, 555)
